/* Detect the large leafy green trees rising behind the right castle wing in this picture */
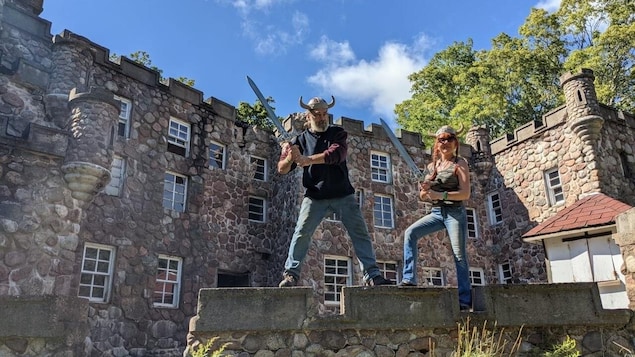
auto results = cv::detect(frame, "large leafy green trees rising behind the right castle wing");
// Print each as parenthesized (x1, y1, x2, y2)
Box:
(395, 0, 635, 137)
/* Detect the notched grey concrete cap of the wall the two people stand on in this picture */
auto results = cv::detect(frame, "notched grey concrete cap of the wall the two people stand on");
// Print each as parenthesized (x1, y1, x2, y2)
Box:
(190, 283, 633, 334)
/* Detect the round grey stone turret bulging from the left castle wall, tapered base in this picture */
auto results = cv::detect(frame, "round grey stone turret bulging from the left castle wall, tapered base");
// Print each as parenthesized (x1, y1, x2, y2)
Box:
(62, 88, 119, 203)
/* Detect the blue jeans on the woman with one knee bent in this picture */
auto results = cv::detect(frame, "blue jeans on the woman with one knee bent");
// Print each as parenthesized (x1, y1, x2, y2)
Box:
(403, 206, 472, 306)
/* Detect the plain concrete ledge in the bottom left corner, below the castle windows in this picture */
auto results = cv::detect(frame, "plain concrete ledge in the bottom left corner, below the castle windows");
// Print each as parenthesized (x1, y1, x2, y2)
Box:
(0, 295, 89, 342)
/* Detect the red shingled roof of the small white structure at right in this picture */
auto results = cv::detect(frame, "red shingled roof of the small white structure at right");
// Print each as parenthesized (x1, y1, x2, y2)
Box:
(523, 193, 632, 238)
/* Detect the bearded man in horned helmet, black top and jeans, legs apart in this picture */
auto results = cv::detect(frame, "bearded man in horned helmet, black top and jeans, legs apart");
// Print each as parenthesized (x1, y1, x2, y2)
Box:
(278, 97, 392, 287)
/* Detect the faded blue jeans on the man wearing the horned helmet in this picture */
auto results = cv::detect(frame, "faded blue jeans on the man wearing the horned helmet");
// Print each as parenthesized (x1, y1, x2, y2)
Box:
(284, 194, 380, 281)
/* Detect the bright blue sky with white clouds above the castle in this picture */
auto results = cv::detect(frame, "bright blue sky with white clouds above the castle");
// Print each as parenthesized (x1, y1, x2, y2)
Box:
(40, 0, 560, 126)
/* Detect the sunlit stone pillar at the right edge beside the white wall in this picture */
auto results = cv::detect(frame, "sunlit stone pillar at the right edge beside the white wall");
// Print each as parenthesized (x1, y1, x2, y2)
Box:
(613, 208, 635, 310)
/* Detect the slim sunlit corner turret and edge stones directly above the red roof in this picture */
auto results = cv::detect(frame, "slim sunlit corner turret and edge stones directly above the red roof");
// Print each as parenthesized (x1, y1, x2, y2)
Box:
(560, 69, 604, 194)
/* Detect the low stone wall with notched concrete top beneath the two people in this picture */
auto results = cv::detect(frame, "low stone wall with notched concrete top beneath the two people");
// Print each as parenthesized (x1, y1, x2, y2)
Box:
(186, 283, 635, 357)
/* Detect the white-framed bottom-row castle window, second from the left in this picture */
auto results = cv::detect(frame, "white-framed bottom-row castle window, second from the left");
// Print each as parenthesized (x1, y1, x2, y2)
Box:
(152, 255, 182, 307)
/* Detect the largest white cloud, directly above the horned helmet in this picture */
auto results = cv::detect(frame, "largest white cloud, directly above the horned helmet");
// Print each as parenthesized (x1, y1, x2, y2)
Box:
(308, 35, 430, 119)
